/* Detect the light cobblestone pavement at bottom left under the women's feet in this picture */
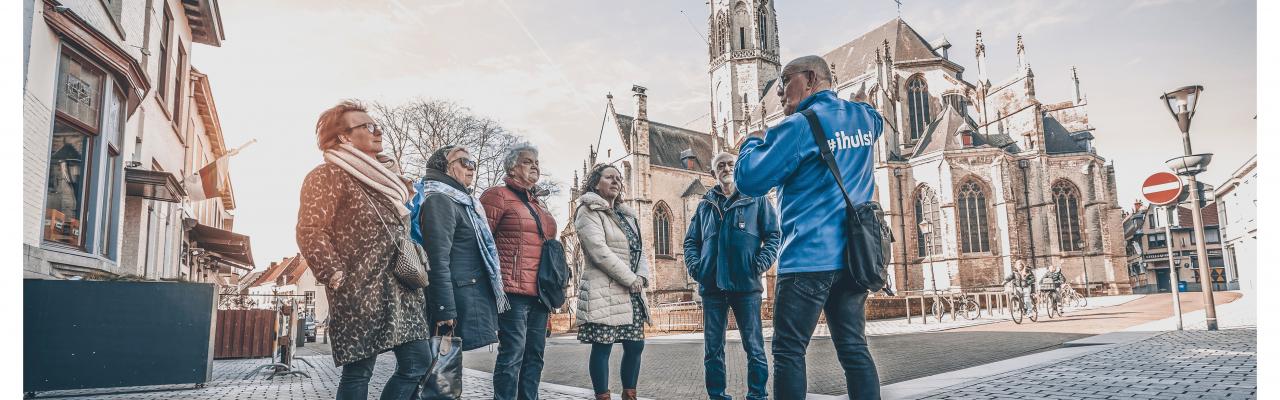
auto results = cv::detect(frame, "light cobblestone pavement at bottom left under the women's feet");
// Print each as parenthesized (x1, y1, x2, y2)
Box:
(30, 347, 606, 400)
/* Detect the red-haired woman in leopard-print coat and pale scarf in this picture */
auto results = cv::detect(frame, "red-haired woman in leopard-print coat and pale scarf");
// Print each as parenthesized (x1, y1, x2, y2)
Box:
(297, 101, 431, 400)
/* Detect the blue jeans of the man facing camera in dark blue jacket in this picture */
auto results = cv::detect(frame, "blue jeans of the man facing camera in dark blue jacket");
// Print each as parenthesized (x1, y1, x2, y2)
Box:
(703, 292, 769, 400)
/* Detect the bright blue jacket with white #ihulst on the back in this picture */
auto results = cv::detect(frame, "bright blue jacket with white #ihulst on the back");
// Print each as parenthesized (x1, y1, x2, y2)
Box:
(733, 90, 884, 274)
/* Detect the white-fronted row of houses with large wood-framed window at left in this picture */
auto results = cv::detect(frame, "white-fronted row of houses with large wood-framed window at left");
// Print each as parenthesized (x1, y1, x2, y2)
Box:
(23, 0, 253, 285)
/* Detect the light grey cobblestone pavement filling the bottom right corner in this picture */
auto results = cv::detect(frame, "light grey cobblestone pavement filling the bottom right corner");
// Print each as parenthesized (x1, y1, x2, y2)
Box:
(923, 328, 1258, 399)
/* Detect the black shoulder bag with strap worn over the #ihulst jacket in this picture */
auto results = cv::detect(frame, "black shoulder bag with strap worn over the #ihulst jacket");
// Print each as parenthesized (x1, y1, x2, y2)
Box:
(800, 109, 893, 296)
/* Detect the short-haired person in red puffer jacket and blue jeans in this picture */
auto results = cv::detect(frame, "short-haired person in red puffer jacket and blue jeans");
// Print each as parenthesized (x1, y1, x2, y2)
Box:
(480, 144, 556, 399)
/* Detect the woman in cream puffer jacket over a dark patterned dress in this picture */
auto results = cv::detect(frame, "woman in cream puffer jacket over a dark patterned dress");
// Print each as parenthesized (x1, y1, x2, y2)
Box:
(573, 164, 650, 399)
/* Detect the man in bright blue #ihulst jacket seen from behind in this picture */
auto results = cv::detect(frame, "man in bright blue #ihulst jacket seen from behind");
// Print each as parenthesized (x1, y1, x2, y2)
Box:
(735, 55, 883, 400)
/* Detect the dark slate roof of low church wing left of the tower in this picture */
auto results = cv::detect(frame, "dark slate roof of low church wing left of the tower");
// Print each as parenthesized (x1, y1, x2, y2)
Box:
(617, 114, 716, 172)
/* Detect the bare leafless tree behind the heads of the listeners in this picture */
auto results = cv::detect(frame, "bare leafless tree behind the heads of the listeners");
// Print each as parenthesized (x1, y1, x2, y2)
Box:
(370, 99, 520, 192)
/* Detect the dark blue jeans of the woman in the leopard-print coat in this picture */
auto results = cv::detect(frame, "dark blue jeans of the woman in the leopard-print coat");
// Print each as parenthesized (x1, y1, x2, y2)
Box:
(338, 340, 431, 400)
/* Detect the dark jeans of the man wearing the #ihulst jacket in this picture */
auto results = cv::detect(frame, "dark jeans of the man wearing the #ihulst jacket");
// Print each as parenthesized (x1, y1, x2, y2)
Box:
(773, 269, 879, 400)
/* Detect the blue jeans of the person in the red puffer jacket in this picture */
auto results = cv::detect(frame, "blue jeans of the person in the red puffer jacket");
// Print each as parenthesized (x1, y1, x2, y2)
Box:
(493, 294, 549, 400)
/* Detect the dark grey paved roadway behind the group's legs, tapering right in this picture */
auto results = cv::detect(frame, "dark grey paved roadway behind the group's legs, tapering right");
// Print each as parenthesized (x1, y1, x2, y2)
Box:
(462, 332, 1089, 399)
